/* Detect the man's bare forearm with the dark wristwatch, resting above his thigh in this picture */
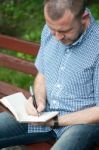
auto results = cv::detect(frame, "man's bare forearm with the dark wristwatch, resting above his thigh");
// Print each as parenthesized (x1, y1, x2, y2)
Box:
(58, 107, 99, 126)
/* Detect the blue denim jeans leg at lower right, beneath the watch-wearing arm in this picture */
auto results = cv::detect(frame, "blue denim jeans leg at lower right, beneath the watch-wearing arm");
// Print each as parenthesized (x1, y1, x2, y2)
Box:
(51, 124, 99, 150)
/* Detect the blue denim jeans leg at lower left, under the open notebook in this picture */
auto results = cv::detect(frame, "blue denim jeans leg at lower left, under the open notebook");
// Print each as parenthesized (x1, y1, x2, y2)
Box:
(0, 112, 56, 148)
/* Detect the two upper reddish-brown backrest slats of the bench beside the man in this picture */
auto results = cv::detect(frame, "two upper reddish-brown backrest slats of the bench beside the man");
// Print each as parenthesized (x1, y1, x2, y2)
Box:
(0, 35, 39, 75)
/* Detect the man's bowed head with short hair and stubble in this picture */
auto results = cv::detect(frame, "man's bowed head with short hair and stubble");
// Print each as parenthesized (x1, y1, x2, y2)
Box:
(44, 0, 89, 44)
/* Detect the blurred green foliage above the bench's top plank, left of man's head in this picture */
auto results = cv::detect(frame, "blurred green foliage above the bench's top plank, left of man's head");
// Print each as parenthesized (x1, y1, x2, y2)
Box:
(0, 0, 44, 41)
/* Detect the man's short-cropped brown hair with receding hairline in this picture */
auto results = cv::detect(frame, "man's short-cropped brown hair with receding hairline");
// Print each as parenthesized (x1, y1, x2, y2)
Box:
(44, 0, 86, 20)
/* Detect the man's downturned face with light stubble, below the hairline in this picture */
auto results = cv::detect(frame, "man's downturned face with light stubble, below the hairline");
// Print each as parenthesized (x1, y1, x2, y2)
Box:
(44, 8, 83, 45)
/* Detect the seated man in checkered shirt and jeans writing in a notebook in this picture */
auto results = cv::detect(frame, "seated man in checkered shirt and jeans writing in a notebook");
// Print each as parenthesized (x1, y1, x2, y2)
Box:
(0, 0, 99, 150)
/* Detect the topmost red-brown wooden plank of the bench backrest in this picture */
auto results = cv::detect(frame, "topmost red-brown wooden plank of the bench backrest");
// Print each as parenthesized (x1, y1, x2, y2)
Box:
(0, 35, 39, 56)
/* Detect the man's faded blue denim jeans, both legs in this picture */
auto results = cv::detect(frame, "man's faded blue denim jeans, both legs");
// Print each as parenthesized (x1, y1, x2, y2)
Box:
(0, 112, 99, 150)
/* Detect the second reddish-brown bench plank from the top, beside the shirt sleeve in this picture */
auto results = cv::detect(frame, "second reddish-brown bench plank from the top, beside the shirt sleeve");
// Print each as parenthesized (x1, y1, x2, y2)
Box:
(0, 53, 37, 75)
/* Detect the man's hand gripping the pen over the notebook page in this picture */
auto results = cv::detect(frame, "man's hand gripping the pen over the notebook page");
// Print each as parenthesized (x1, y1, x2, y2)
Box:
(26, 97, 45, 116)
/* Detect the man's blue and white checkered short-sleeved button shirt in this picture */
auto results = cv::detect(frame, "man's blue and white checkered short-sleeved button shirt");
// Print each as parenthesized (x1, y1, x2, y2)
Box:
(28, 11, 99, 138)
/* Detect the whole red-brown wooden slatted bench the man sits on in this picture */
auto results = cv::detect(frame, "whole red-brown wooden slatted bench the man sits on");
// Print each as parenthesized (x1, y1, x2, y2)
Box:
(0, 35, 99, 150)
